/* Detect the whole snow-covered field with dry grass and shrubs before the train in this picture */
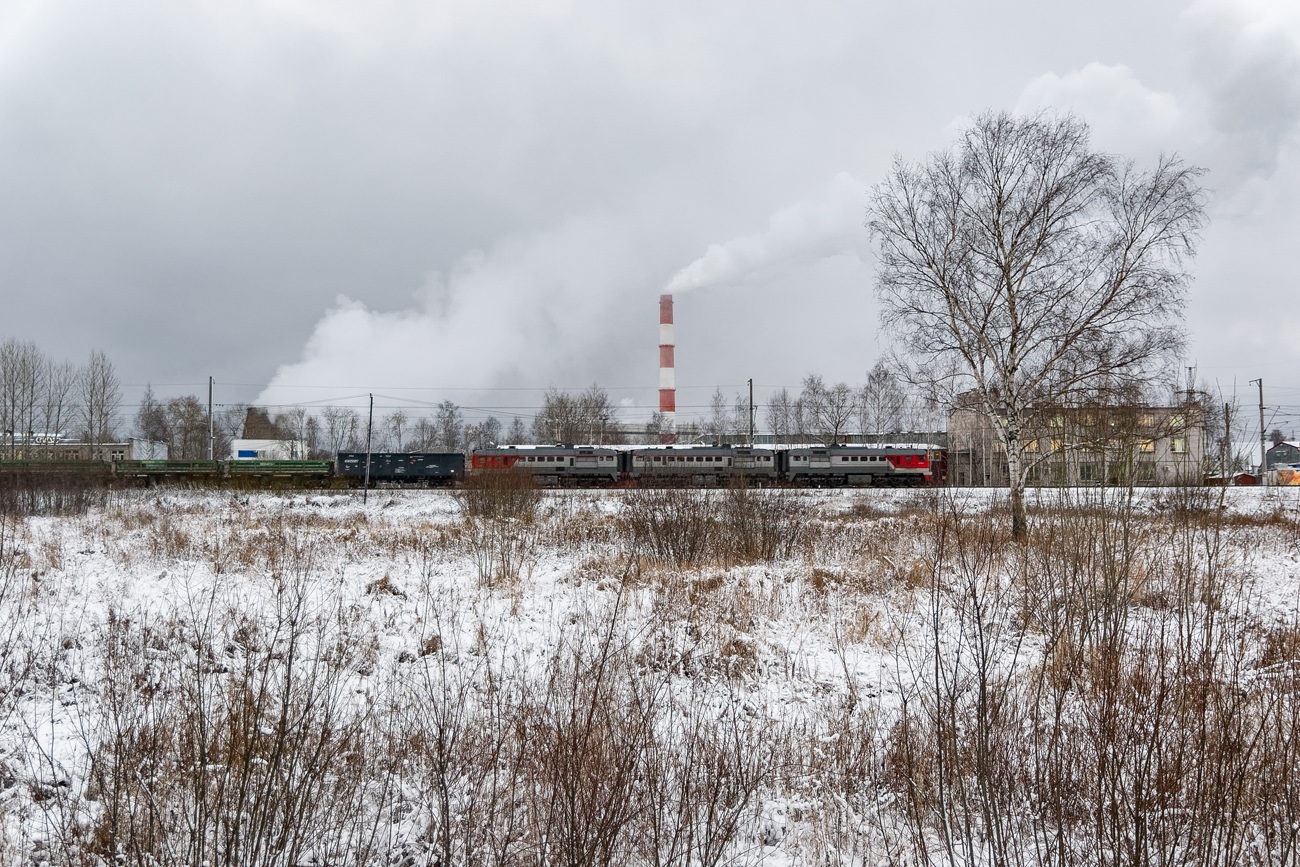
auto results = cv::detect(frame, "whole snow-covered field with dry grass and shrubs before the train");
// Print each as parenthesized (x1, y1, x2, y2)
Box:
(0, 489, 1300, 866)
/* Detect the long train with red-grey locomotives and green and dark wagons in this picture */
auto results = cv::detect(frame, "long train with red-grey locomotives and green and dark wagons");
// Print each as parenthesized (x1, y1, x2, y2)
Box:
(0, 445, 943, 487)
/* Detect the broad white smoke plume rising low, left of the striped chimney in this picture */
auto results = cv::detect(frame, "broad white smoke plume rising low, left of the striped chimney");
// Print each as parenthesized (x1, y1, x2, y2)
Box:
(257, 217, 653, 404)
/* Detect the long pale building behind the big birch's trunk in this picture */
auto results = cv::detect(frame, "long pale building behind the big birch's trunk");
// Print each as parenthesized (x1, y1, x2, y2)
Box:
(948, 393, 1205, 486)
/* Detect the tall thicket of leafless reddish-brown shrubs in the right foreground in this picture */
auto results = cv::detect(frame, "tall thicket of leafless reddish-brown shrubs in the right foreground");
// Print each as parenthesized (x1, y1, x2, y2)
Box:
(868, 488, 1300, 864)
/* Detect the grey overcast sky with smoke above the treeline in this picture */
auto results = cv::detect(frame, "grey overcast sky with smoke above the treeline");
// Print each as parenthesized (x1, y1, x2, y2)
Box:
(0, 0, 1300, 429)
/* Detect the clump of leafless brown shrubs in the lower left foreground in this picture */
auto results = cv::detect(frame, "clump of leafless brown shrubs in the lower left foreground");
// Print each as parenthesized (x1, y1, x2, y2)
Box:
(68, 572, 391, 864)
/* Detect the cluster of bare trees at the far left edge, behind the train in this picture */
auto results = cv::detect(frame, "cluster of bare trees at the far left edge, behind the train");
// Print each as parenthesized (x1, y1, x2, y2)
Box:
(0, 339, 122, 456)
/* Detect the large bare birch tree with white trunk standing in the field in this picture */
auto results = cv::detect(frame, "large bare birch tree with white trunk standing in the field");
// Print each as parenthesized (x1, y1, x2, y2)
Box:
(867, 112, 1205, 541)
